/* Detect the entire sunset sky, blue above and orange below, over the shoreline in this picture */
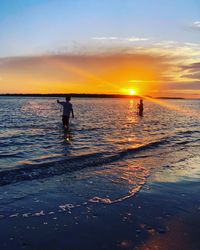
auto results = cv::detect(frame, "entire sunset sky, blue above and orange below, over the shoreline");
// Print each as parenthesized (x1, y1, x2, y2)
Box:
(0, 0, 200, 98)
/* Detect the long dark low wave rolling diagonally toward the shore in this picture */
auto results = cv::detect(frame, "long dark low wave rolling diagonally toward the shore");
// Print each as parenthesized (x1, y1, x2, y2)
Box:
(0, 139, 168, 186)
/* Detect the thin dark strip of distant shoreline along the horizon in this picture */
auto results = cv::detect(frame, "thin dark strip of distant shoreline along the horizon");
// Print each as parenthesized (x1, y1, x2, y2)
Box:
(0, 93, 186, 99)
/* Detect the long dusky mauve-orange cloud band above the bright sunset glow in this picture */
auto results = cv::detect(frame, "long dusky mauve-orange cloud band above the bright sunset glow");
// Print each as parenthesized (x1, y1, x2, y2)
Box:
(0, 50, 171, 81)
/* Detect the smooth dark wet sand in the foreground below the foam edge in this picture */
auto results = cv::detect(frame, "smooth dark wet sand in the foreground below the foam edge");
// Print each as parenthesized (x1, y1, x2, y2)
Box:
(0, 161, 200, 250)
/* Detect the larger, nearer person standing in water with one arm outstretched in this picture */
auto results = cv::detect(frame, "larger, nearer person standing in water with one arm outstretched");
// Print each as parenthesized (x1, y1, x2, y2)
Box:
(57, 96, 74, 130)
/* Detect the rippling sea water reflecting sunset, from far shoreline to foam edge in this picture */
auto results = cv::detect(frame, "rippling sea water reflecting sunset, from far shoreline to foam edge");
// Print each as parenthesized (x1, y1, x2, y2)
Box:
(0, 97, 200, 216)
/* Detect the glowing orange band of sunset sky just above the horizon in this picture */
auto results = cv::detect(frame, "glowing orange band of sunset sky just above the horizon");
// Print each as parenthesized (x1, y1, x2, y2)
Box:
(0, 47, 200, 97)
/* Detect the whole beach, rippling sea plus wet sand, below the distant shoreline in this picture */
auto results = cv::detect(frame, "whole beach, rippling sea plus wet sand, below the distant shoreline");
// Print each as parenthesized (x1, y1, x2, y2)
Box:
(0, 97, 200, 250)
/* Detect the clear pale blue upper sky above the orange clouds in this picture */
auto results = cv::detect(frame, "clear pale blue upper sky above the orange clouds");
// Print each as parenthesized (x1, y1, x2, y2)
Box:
(0, 0, 200, 57)
